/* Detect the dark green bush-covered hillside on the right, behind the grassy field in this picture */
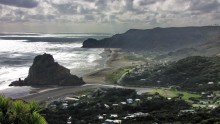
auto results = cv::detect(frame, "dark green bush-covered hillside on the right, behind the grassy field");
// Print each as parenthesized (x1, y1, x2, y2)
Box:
(124, 56, 220, 91)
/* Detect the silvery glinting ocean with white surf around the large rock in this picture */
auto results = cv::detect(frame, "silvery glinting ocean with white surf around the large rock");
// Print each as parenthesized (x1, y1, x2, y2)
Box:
(0, 33, 111, 93)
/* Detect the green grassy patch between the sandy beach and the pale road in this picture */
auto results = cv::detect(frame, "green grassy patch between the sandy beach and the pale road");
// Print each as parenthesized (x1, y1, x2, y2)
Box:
(106, 67, 132, 83)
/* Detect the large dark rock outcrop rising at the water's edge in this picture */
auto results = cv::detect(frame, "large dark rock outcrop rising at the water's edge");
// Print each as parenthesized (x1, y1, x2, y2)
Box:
(10, 54, 84, 86)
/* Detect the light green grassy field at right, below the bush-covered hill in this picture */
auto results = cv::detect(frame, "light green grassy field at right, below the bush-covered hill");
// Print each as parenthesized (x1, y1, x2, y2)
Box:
(152, 88, 201, 102)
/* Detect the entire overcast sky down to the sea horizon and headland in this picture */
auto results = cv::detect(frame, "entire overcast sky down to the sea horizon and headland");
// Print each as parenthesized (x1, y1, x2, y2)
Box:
(0, 0, 220, 34)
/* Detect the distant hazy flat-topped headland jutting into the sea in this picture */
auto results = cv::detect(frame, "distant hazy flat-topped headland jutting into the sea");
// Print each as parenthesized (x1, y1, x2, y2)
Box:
(83, 26, 220, 51)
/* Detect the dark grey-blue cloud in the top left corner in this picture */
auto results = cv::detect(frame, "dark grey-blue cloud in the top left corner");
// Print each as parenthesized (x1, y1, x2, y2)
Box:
(0, 0, 38, 8)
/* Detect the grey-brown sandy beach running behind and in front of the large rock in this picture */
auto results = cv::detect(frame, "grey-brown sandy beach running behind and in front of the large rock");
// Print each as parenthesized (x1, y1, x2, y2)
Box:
(3, 48, 148, 103)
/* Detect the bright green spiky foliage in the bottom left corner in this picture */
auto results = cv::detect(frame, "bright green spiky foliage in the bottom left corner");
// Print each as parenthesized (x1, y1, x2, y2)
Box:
(0, 96, 47, 124)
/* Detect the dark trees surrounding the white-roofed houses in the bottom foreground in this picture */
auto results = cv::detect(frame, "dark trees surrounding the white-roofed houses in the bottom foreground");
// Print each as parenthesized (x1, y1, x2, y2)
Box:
(43, 88, 196, 124)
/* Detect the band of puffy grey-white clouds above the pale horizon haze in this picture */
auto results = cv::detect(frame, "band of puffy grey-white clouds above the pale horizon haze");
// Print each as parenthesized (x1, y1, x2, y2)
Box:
(0, 0, 220, 32)
